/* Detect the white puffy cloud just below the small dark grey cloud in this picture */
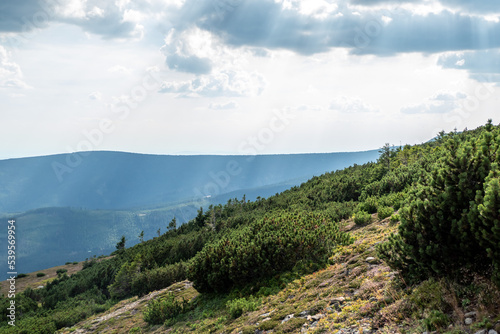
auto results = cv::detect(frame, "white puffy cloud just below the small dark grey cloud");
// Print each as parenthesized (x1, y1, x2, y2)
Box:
(159, 70, 266, 97)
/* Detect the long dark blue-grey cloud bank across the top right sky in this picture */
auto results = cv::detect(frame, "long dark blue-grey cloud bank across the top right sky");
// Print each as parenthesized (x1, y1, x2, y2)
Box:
(174, 0, 500, 55)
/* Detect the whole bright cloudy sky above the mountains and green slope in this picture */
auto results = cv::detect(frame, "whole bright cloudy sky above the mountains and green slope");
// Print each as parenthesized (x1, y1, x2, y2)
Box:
(0, 0, 500, 159)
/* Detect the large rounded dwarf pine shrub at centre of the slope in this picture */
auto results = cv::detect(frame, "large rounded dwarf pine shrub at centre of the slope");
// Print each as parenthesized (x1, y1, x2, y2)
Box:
(188, 211, 352, 292)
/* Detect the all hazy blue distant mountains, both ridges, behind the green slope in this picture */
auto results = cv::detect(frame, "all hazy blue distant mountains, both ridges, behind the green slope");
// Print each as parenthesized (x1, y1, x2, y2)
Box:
(0, 150, 379, 272)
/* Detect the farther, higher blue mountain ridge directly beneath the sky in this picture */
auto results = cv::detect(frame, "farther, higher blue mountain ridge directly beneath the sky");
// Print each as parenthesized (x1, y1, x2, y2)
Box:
(0, 150, 378, 213)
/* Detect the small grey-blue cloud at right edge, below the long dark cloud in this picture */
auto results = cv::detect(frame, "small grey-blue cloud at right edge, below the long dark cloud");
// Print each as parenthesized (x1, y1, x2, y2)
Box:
(438, 49, 500, 83)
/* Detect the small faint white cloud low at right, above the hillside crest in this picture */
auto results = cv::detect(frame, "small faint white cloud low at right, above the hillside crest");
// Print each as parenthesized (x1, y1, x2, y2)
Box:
(401, 92, 467, 114)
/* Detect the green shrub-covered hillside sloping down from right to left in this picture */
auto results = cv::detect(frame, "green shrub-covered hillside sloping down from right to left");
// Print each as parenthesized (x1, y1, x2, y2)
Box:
(0, 122, 500, 333)
